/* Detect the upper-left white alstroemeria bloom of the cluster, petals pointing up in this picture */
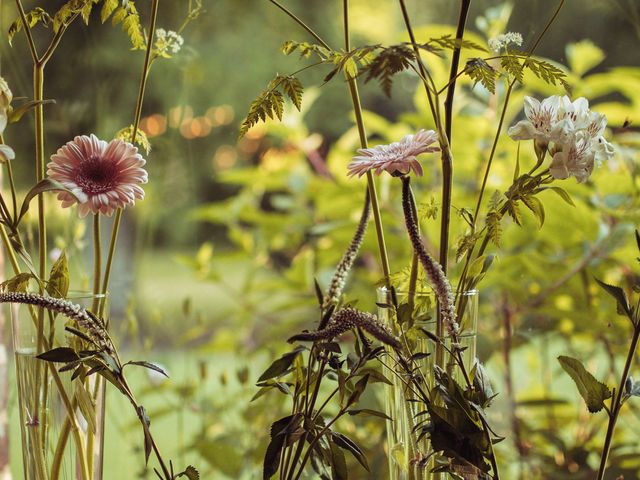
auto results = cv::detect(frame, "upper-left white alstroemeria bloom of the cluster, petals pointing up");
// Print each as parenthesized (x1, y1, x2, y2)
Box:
(507, 95, 573, 143)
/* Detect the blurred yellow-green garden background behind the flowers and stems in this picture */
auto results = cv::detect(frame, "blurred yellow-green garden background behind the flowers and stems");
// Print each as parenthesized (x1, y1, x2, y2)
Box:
(0, 0, 640, 479)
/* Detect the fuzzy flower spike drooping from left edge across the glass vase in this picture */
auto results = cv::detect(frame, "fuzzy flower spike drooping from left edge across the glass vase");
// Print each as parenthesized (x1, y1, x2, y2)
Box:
(0, 292, 115, 353)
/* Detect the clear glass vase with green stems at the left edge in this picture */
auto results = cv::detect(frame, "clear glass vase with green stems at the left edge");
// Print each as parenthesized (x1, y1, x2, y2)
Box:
(10, 292, 107, 480)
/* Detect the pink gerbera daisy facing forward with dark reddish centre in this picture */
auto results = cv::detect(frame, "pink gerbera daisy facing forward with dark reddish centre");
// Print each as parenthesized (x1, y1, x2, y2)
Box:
(47, 134, 147, 217)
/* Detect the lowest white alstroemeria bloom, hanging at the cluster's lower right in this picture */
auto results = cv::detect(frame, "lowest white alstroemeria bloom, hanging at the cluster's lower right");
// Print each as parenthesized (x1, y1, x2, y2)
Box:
(549, 131, 596, 183)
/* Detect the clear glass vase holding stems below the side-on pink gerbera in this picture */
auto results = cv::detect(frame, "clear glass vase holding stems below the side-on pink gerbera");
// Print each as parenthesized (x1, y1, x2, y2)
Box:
(377, 287, 478, 480)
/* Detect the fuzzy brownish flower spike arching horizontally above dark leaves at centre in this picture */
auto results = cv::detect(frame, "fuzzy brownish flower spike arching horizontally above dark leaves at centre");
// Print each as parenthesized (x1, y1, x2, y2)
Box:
(288, 307, 400, 349)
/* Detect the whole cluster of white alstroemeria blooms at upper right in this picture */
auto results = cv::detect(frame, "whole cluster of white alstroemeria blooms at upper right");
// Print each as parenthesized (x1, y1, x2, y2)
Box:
(508, 95, 614, 183)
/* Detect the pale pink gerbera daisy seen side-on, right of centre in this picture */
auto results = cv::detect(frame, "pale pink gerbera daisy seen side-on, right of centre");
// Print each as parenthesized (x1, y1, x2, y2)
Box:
(347, 130, 440, 177)
